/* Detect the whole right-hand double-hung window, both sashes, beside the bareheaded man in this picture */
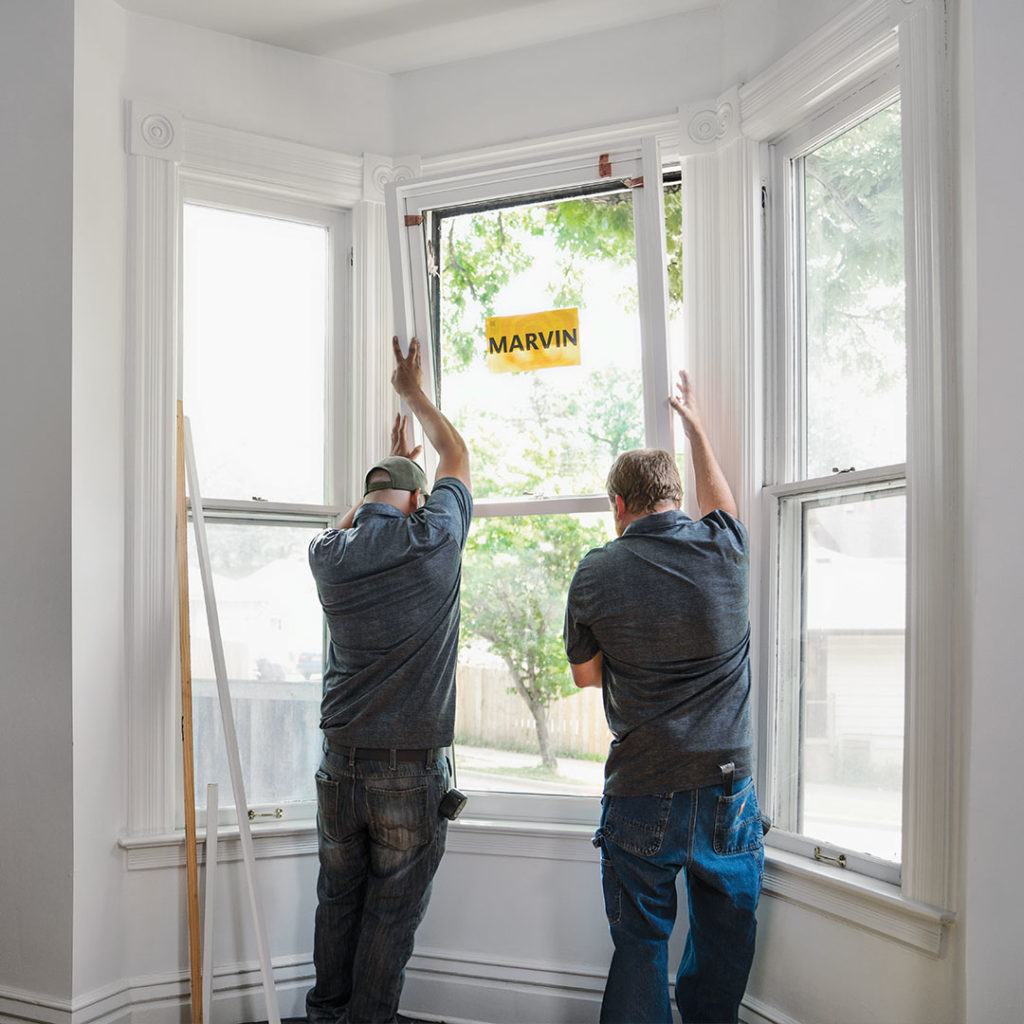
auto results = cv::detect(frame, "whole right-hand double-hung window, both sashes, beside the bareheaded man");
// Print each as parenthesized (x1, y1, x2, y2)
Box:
(766, 78, 907, 882)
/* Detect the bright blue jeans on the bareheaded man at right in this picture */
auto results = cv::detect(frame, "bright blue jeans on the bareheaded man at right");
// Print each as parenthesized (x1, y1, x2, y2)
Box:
(595, 778, 764, 1024)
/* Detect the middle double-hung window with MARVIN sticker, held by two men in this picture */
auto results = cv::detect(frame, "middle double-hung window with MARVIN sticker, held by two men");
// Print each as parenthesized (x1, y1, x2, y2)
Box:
(392, 140, 681, 818)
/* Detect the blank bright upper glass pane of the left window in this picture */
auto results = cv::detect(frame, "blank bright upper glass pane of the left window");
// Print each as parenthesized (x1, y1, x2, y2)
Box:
(182, 204, 329, 504)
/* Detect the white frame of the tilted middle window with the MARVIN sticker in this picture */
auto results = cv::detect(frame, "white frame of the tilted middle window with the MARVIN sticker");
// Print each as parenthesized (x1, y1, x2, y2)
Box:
(387, 134, 674, 827)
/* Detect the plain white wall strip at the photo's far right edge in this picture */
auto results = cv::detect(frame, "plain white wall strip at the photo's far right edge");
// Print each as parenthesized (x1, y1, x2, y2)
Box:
(963, 0, 1024, 1021)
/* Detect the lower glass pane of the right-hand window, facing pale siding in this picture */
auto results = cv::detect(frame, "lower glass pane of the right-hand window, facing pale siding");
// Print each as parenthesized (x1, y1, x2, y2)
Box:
(799, 490, 906, 861)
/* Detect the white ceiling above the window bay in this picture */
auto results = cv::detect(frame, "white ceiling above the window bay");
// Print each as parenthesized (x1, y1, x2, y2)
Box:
(118, 0, 722, 74)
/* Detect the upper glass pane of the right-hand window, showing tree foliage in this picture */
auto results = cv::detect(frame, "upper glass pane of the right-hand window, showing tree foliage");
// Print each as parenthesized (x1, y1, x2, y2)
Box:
(798, 102, 906, 477)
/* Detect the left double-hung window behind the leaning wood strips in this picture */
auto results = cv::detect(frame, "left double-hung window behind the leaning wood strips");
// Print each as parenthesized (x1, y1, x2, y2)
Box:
(181, 182, 349, 818)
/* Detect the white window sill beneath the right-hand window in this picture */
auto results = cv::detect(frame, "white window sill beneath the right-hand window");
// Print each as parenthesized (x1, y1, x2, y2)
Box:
(764, 847, 956, 957)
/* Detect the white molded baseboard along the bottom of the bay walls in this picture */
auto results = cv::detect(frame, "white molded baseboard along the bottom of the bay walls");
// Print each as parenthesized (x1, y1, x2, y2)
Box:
(0, 949, 801, 1024)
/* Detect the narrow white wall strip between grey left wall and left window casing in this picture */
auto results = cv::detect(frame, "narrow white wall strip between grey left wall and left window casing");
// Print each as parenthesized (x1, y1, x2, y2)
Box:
(71, 0, 126, 996)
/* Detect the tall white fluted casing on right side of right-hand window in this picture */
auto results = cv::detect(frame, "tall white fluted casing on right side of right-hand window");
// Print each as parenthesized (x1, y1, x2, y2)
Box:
(899, 0, 969, 909)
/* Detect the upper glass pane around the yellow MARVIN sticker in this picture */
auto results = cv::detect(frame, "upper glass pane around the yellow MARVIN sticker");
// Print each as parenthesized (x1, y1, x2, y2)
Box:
(435, 191, 643, 498)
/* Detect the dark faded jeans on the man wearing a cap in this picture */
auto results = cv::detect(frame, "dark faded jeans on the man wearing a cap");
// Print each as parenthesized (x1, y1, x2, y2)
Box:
(306, 751, 449, 1024)
